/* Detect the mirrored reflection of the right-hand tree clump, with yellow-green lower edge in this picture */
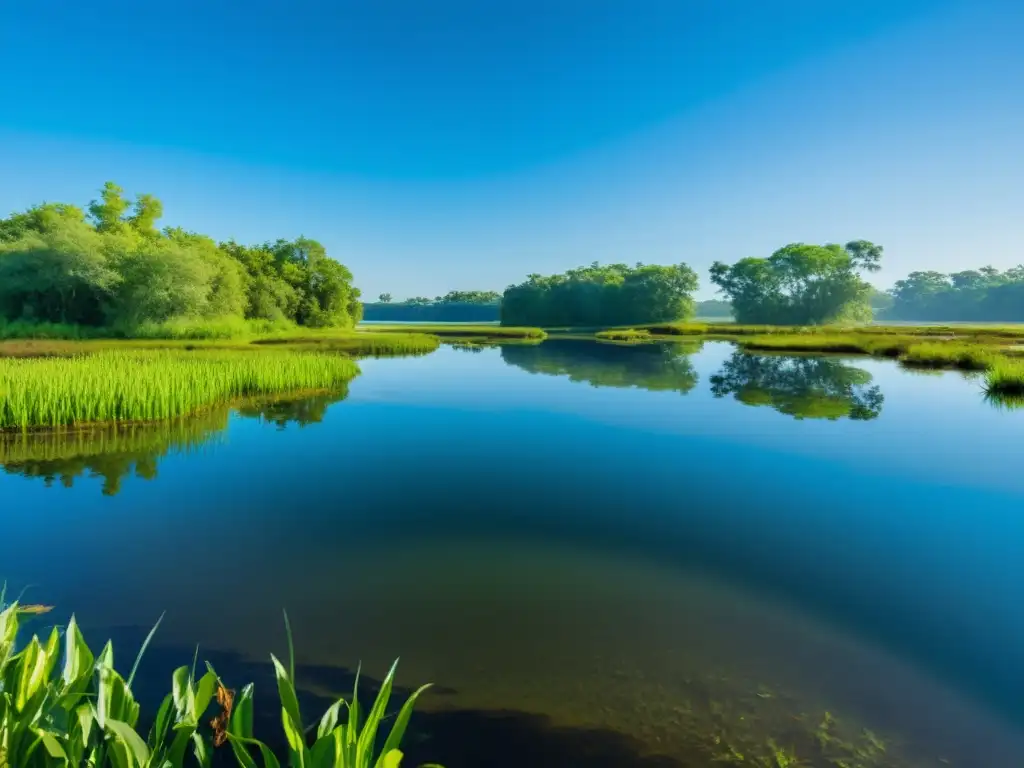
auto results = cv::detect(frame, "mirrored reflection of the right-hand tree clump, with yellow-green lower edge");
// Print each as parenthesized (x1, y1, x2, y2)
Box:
(711, 351, 885, 421)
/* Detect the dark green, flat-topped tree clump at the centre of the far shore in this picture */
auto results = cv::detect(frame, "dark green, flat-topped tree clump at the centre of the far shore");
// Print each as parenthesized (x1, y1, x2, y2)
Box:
(502, 261, 697, 327)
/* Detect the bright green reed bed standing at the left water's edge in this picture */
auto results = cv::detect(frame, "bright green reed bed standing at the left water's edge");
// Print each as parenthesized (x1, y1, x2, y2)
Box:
(0, 350, 358, 429)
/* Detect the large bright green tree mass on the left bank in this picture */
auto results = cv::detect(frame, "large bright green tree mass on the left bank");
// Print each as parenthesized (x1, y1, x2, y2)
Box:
(0, 182, 361, 333)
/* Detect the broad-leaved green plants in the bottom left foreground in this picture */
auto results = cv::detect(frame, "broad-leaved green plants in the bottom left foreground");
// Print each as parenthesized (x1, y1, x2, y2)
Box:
(0, 606, 429, 768)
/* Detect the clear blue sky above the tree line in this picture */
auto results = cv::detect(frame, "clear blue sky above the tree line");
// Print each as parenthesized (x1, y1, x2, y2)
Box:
(0, 0, 1024, 297)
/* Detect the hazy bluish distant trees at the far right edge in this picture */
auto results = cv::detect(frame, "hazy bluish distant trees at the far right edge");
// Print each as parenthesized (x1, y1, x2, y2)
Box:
(886, 264, 1024, 322)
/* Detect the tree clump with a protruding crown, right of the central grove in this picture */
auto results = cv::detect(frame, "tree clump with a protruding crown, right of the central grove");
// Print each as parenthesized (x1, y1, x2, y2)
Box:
(711, 240, 882, 326)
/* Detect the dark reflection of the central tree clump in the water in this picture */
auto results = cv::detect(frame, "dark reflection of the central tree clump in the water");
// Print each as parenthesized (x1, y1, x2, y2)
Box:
(502, 340, 700, 394)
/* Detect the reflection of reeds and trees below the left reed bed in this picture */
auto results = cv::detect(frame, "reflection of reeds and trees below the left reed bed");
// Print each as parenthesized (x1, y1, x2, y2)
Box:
(0, 387, 348, 496)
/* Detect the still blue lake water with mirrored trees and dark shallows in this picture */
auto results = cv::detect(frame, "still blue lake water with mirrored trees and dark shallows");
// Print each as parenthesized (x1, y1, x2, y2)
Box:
(0, 341, 1024, 768)
